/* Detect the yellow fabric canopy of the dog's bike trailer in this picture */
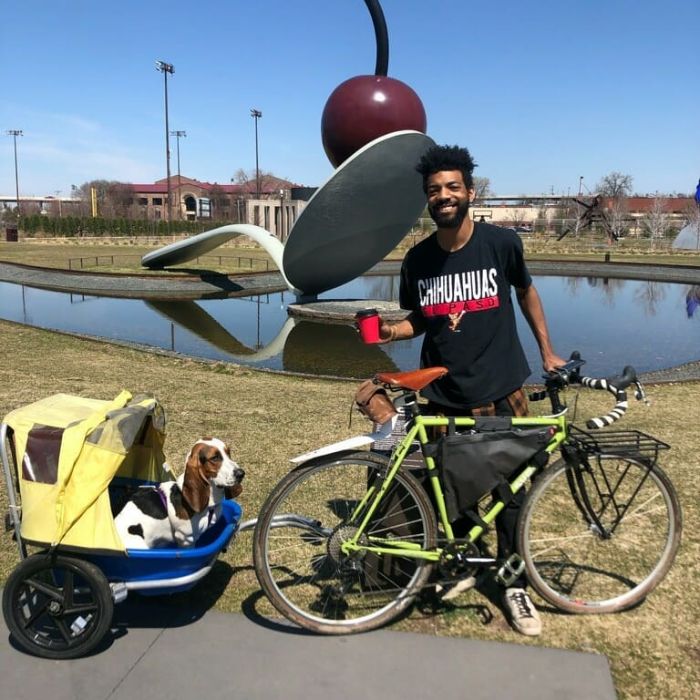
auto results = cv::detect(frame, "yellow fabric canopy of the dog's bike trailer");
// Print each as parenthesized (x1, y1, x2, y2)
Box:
(4, 391, 172, 552)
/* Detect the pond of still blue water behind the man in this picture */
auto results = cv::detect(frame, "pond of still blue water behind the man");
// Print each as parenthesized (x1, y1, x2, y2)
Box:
(0, 275, 700, 382)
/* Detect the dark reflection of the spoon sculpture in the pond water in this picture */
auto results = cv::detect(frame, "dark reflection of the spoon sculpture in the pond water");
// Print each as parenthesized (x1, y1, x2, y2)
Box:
(144, 300, 399, 378)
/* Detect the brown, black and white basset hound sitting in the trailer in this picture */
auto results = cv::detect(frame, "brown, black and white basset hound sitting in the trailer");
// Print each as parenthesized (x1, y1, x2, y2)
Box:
(114, 438, 245, 549)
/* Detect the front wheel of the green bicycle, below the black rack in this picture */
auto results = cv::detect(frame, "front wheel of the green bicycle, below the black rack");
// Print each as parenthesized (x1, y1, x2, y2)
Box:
(518, 454, 681, 613)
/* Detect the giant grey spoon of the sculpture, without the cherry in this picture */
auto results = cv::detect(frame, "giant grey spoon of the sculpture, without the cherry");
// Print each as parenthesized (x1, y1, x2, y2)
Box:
(141, 131, 434, 296)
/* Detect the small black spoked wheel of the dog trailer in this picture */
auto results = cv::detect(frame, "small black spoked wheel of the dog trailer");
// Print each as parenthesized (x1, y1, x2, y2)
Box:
(2, 553, 114, 659)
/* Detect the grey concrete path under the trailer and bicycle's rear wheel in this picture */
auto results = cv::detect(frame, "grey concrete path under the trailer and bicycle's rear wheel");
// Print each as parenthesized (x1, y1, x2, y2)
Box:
(0, 596, 616, 700)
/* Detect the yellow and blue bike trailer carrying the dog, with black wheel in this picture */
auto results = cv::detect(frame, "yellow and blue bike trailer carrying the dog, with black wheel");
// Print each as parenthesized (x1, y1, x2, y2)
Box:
(0, 391, 241, 659)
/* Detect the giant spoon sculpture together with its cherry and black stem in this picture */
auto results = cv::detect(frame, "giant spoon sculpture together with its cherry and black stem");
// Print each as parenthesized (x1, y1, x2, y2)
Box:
(141, 0, 433, 297)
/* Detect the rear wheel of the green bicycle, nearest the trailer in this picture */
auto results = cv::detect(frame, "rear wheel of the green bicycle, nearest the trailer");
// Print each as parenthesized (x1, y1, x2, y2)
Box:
(253, 452, 437, 634)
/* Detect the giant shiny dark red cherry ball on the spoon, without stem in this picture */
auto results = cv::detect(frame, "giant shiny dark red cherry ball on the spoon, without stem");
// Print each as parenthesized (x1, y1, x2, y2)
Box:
(321, 75, 427, 168)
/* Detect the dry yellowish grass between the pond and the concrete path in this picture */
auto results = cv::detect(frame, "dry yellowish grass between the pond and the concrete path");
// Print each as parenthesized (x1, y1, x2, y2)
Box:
(0, 324, 700, 698)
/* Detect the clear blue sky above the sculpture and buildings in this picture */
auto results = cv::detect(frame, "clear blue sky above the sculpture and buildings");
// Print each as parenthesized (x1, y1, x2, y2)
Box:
(0, 0, 700, 196)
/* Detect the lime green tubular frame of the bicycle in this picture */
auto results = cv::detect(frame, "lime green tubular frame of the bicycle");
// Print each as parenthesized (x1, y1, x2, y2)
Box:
(341, 414, 568, 562)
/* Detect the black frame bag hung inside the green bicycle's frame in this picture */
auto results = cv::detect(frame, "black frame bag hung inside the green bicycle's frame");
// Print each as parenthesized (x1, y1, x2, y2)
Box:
(428, 416, 553, 522)
